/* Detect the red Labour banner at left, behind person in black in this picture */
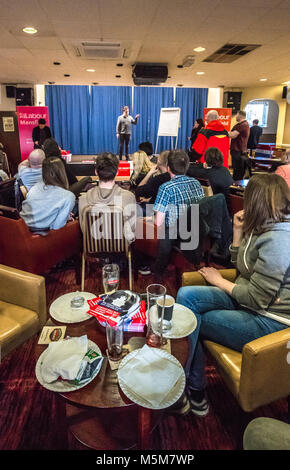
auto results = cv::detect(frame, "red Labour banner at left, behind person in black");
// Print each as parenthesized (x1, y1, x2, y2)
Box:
(16, 106, 49, 160)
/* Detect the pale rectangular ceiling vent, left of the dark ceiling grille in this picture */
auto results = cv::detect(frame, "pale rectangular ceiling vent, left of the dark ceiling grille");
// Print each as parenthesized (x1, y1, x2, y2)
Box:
(75, 42, 125, 59)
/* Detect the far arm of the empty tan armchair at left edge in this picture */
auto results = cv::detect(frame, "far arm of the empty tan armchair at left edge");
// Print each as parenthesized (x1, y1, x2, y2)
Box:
(0, 264, 47, 327)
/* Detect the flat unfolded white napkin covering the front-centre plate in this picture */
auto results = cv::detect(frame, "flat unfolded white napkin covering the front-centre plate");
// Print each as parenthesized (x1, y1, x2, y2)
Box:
(118, 344, 183, 407)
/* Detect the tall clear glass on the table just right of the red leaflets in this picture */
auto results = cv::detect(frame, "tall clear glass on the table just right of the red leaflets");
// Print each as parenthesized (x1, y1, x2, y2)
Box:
(146, 284, 166, 348)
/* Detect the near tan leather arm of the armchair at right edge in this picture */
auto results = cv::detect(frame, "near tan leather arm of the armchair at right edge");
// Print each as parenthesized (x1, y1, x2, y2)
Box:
(239, 328, 290, 411)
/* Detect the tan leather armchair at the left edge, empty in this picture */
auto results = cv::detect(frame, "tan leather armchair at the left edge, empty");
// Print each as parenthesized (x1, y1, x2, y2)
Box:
(0, 264, 47, 358)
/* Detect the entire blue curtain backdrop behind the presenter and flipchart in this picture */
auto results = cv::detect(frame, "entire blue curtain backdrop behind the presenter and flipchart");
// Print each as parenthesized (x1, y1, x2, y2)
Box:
(45, 85, 208, 155)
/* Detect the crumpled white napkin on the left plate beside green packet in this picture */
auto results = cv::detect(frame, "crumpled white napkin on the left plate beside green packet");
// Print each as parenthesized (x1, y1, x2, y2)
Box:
(41, 335, 88, 383)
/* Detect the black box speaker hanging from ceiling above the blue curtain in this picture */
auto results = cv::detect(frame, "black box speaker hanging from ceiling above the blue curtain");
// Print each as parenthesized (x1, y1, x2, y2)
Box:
(132, 63, 168, 85)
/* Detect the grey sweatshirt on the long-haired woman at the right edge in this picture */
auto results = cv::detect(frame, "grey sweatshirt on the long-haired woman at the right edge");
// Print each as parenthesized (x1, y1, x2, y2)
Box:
(230, 218, 290, 326)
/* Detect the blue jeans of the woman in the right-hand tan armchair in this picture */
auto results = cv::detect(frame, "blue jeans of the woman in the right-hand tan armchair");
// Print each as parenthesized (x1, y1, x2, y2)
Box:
(176, 286, 287, 390)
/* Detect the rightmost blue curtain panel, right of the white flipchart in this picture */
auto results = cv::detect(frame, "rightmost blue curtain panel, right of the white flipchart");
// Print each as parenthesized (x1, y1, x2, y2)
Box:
(174, 88, 208, 149)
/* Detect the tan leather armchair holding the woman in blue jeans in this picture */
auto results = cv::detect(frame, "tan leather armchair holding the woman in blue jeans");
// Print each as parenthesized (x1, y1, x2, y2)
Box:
(182, 269, 290, 412)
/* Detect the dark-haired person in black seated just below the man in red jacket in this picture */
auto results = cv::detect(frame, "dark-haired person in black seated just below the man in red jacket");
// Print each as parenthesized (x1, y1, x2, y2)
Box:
(187, 147, 234, 199)
